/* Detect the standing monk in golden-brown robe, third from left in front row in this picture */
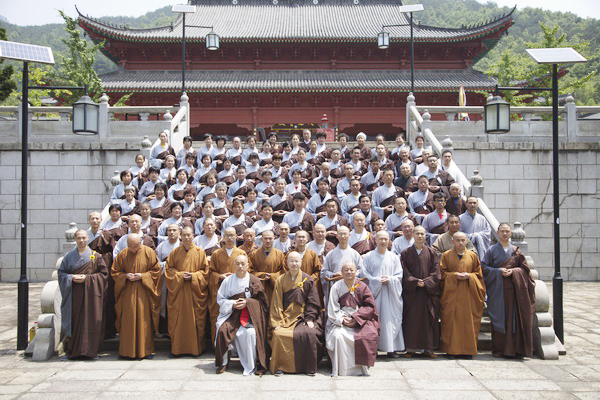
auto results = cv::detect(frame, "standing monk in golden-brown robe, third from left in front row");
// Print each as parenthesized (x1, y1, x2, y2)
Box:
(165, 226, 208, 356)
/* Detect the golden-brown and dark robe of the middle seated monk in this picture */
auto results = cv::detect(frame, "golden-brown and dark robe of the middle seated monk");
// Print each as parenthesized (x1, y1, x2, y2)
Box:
(269, 271, 323, 373)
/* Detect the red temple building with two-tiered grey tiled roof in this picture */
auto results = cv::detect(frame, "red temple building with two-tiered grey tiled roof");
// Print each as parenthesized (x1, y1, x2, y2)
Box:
(79, 0, 513, 138)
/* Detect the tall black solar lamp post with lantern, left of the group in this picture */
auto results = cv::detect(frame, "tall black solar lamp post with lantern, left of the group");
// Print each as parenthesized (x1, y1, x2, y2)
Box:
(0, 40, 98, 350)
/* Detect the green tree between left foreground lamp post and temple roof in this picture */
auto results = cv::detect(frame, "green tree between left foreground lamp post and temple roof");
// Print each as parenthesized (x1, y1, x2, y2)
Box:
(54, 11, 104, 105)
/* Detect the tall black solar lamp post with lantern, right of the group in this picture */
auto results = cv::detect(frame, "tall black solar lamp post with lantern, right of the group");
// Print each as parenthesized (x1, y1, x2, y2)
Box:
(485, 47, 587, 344)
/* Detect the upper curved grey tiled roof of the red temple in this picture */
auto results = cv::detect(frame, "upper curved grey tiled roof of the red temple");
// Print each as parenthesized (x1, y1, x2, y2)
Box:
(79, 1, 512, 43)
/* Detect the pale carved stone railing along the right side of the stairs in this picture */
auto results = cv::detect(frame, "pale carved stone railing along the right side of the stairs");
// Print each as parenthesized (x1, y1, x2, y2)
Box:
(407, 94, 563, 359)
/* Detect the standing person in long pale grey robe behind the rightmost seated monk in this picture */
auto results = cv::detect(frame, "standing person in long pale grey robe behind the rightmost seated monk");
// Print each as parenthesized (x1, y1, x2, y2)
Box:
(364, 231, 404, 358)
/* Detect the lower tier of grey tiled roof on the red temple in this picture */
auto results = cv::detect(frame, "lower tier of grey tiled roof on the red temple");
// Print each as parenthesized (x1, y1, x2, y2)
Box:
(101, 70, 496, 93)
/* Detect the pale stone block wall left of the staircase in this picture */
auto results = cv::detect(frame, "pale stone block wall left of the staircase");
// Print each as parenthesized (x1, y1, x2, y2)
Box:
(0, 144, 140, 282)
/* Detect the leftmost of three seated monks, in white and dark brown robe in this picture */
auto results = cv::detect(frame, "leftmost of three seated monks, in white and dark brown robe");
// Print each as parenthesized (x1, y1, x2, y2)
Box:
(215, 254, 268, 376)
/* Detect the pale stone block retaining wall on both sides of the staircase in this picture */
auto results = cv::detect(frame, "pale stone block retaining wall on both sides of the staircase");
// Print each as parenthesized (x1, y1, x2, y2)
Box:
(0, 141, 600, 281)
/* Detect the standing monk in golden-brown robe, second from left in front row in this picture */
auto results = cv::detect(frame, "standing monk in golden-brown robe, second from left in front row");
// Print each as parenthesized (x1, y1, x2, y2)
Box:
(111, 233, 162, 358)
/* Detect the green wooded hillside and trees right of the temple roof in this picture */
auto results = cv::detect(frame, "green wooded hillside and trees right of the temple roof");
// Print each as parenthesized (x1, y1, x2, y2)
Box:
(412, 0, 600, 105)
